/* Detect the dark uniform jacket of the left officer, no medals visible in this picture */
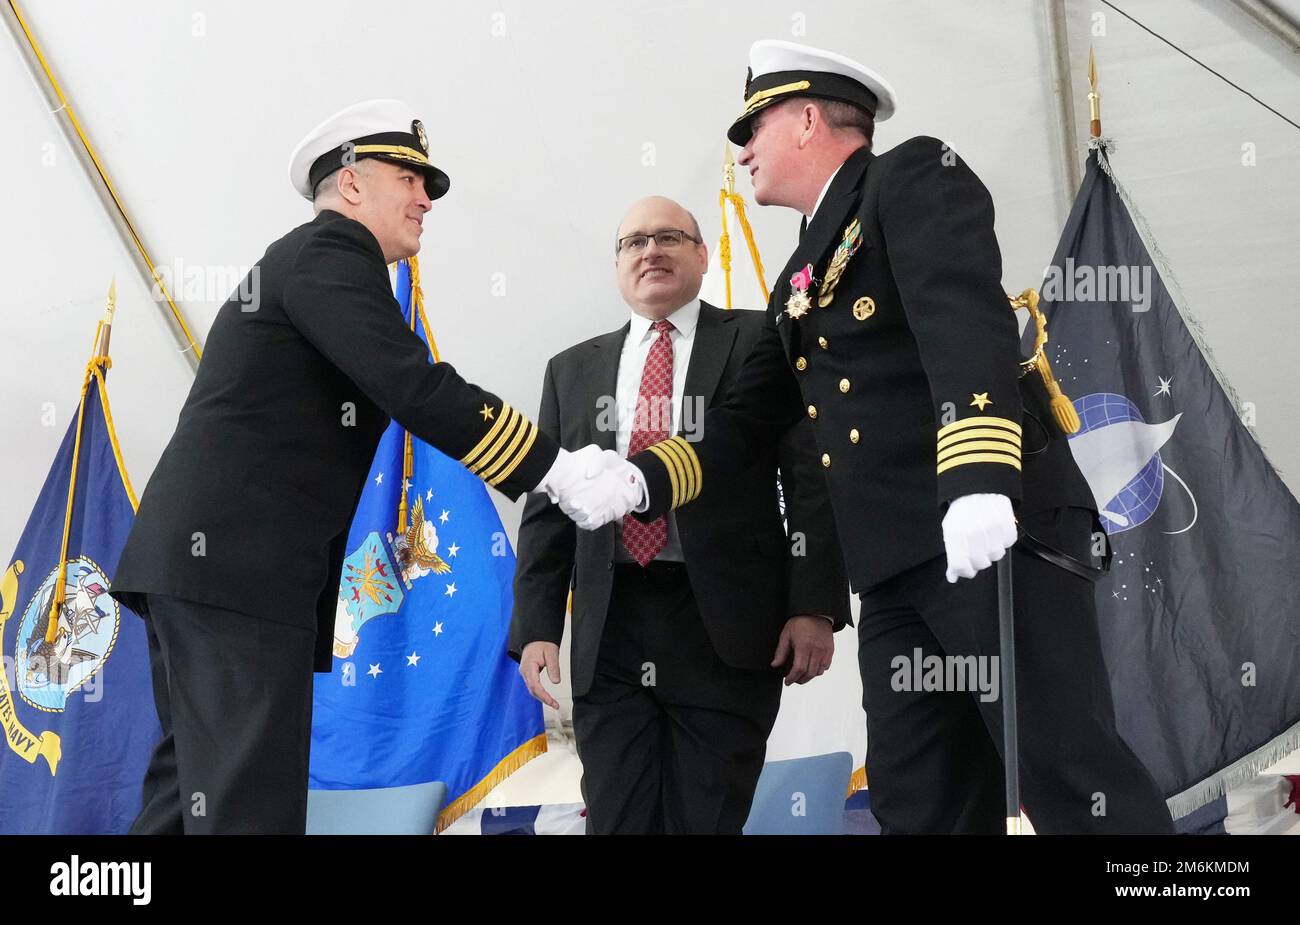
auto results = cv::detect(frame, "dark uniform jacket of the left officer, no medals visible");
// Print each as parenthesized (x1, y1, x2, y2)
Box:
(112, 210, 558, 670)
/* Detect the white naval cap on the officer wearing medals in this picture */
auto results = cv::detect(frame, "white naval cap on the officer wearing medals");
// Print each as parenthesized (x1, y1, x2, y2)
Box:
(727, 39, 897, 146)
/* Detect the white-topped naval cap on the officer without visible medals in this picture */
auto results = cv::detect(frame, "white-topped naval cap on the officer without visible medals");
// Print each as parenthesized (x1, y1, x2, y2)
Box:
(289, 100, 451, 199)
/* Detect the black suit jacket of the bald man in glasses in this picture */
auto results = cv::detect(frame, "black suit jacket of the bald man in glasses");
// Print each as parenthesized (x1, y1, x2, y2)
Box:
(510, 303, 849, 696)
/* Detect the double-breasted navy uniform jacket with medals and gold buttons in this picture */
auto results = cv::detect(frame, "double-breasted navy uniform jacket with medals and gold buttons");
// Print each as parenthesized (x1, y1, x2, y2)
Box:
(632, 136, 1095, 591)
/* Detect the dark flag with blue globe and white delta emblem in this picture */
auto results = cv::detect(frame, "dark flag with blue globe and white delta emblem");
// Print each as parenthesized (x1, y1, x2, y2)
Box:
(1041, 149, 1300, 817)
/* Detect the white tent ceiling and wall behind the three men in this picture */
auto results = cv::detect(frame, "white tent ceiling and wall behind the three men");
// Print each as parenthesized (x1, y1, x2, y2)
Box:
(0, 0, 1300, 546)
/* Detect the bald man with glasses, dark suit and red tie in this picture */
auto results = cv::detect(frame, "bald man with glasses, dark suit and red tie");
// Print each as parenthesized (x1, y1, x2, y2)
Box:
(510, 196, 849, 834)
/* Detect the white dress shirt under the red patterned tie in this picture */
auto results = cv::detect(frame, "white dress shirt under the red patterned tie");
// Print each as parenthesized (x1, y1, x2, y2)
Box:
(614, 299, 703, 563)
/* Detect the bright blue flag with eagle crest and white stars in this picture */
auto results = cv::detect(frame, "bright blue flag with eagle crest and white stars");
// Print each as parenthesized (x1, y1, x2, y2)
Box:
(311, 262, 546, 829)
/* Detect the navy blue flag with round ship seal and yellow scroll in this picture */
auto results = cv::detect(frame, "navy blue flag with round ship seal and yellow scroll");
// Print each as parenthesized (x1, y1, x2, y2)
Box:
(0, 358, 163, 834)
